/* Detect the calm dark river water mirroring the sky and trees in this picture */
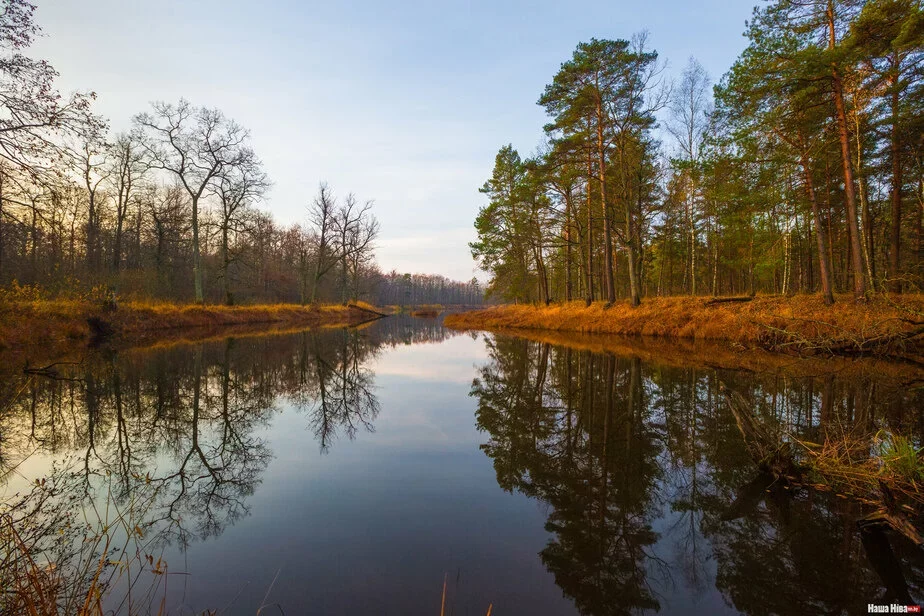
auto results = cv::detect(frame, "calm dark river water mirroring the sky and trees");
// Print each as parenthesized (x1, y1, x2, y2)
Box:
(0, 318, 924, 615)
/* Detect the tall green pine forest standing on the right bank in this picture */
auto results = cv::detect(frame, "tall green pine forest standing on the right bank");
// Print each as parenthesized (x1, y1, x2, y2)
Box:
(471, 0, 924, 305)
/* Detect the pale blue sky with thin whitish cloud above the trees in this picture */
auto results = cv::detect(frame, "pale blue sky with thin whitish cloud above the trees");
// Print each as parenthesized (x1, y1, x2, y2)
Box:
(34, 0, 753, 279)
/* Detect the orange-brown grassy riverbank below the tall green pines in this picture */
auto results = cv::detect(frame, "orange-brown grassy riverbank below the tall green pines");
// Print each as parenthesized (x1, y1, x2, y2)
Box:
(444, 294, 924, 357)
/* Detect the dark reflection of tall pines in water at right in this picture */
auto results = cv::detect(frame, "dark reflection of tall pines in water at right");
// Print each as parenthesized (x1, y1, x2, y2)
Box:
(472, 336, 924, 614)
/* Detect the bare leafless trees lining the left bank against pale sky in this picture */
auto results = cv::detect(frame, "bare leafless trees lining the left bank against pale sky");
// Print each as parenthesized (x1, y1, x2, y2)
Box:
(0, 0, 482, 304)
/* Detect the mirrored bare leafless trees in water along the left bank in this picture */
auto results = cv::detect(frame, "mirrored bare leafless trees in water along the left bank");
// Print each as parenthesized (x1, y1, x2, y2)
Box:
(0, 319, 460, 610)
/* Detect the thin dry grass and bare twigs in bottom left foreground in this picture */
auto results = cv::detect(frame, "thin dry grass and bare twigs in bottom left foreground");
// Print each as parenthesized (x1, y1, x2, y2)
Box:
(0, 473, 167, 616)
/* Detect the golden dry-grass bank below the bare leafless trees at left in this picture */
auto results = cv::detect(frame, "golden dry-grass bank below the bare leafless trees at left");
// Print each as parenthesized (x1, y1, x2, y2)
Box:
(0, 300, 377, 350)
